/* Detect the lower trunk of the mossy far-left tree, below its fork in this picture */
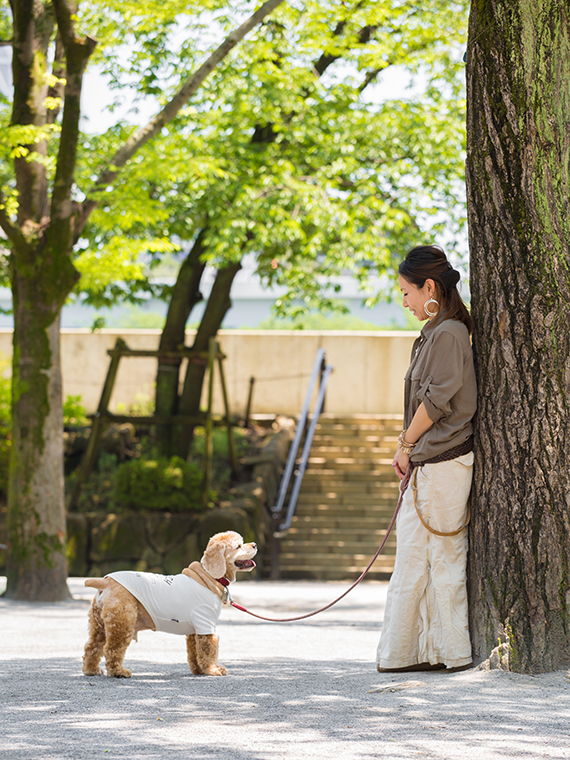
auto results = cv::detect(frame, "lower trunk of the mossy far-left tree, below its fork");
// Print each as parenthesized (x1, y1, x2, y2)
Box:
(6, 274, 69, 602)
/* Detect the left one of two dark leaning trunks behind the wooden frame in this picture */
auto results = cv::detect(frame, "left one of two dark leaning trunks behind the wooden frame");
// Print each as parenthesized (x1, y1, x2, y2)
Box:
(155, 230, 206, 457)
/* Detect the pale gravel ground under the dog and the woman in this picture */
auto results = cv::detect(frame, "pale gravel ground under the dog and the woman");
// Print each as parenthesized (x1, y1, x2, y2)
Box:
(0, 578, 570, 760)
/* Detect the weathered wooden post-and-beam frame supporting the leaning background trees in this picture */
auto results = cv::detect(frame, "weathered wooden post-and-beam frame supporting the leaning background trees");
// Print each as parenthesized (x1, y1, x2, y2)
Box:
(68, 338, 237, 508)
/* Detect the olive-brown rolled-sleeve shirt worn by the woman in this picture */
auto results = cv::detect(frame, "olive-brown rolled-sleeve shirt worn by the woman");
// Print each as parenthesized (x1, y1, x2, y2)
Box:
(404, 319, 477, 462)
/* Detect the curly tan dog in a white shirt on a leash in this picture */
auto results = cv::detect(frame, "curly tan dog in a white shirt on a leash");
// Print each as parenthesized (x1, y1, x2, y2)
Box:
(83, 531, 257, 678)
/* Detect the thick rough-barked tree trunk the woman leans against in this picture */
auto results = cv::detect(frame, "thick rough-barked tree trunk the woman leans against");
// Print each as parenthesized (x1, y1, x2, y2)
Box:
(467, 0, 570, 672)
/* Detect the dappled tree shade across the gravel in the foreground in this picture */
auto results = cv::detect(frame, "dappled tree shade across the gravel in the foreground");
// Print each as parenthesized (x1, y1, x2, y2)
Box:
(0, 658, 570, 760)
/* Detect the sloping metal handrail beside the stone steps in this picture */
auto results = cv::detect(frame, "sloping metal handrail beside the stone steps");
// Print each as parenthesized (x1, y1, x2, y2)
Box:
(271, 348, 333, 578)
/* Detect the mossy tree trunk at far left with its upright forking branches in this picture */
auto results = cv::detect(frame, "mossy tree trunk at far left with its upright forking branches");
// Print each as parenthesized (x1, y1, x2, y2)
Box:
(0, 0, 89, 601)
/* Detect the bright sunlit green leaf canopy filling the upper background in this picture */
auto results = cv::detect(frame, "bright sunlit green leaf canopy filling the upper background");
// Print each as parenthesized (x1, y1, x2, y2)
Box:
(57, 0, 466, 317)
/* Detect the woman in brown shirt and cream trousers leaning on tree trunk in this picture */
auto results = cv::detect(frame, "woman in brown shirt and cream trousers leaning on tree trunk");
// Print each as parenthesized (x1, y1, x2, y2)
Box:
(378, 246, 477, 672)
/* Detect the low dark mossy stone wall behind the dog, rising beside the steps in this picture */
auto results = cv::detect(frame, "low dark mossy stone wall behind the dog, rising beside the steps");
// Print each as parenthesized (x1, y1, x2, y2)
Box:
(0, 418, 294, 578)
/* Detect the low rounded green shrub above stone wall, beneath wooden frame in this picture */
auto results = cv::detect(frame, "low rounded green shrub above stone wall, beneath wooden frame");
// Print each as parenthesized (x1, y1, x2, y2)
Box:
(115, 457, 203, 512)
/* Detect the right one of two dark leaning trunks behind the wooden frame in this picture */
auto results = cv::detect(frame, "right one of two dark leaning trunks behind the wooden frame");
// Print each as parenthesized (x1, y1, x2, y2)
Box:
(174, 262, 241, 459)
